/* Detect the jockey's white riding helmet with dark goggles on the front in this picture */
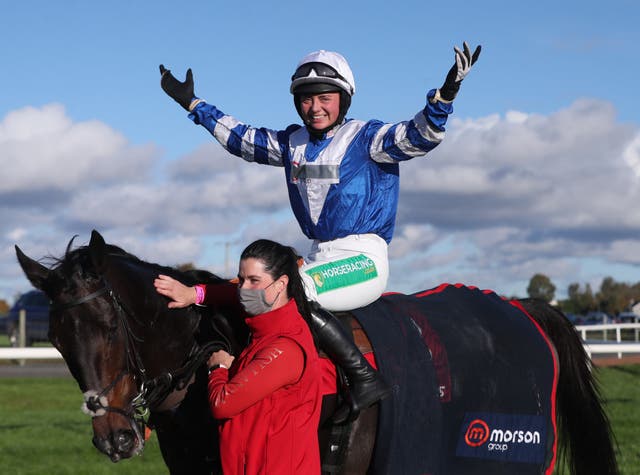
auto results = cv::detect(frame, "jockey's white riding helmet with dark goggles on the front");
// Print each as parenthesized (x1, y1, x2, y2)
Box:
(289, 50, 356, 97)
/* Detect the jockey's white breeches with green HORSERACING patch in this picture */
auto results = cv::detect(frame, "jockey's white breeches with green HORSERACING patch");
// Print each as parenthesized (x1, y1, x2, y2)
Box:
(300, 234, 389, 311)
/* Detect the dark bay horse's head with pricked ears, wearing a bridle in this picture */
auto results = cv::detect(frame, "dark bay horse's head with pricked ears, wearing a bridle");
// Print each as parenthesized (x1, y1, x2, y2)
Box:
(16, 231, 208, 462)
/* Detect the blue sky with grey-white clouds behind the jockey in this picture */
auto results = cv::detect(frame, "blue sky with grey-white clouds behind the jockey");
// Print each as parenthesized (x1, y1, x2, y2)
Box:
(0, 0, 640, 301)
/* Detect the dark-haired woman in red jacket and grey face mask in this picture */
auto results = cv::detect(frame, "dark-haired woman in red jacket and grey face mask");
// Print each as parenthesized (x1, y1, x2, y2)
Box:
(154, 239, 322, 475)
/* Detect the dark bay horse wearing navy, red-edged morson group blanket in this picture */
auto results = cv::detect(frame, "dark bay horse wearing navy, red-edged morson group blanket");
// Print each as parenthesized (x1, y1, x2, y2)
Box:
(16, 231, 617, 475)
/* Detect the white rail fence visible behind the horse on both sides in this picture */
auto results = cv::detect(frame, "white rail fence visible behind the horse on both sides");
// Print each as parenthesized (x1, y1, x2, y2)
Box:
(0, 323, 640, 360)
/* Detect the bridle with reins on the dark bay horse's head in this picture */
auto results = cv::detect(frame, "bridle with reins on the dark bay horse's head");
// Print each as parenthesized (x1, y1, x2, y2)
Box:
(50, 276, 230, 435)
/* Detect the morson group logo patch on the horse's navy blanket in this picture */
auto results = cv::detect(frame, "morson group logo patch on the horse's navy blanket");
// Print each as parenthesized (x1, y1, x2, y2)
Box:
(456, 413, 546, 463)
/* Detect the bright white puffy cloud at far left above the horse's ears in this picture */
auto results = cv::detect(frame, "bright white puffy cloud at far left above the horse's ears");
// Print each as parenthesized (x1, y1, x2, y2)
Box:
(0, 104, 155, 195)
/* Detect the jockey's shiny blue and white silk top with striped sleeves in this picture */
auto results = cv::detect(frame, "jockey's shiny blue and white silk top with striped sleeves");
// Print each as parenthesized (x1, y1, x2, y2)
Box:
(189, 89, 453, 243)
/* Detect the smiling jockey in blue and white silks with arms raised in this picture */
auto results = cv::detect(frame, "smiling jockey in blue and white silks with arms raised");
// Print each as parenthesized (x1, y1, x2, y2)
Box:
(158, 42, 480, 421)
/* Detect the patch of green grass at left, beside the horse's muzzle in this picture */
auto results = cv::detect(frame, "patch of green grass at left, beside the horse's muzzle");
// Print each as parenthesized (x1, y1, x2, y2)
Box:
(0, 378, 167, 475)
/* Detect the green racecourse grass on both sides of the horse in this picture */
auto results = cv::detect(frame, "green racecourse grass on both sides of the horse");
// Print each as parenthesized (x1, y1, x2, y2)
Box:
(0, 365, 640, 475)
